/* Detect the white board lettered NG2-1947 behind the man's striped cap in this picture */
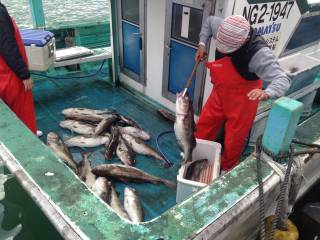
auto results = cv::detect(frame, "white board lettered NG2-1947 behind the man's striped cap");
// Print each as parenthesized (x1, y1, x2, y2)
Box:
(233, 0, 301, 56)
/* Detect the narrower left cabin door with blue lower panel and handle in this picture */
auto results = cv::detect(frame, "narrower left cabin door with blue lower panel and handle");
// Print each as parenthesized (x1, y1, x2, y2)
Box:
(117, 0, 146, 85)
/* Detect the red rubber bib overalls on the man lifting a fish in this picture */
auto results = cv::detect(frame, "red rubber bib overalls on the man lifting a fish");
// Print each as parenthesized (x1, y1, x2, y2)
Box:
(195, 57, 262, 171)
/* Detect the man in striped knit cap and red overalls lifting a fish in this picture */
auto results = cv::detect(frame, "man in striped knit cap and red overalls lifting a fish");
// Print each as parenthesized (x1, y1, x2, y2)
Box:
(195, 15, 291, 172)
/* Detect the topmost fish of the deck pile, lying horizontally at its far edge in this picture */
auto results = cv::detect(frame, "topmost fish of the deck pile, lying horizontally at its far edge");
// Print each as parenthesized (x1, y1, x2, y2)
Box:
(62, 108, 115, 123)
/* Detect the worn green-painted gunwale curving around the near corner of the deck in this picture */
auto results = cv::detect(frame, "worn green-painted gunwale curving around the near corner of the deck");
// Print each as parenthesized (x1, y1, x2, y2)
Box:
(0, 96, 273, 239)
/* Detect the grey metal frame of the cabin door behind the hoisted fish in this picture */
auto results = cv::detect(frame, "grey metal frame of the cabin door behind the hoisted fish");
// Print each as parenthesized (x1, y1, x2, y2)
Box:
(162, 0, 215, 113)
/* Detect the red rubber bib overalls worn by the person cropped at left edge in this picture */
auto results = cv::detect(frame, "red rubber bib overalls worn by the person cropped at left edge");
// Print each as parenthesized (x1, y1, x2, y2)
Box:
(0, 20, 37, 133)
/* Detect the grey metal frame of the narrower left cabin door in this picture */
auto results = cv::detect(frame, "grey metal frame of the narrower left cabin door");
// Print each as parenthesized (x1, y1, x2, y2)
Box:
(117, 0, 147, 85)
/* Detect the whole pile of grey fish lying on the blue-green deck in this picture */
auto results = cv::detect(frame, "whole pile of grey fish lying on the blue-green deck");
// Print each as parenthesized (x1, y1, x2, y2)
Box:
(47, 108, 175, 222)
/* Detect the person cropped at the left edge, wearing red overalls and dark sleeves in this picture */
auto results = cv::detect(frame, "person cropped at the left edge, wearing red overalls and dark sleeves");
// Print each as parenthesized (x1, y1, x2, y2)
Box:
(0, 3, 37, 134)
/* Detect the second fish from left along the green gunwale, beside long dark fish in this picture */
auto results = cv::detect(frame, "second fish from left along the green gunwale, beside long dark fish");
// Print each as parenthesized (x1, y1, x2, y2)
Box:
(78, 153, 96, 188)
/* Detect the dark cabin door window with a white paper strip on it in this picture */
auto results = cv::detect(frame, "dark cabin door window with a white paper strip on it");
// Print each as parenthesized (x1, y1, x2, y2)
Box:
(172, 4, 203, 45)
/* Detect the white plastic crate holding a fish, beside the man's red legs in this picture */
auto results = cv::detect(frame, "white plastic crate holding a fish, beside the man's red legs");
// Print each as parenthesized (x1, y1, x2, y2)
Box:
(176, 139, 221, 203)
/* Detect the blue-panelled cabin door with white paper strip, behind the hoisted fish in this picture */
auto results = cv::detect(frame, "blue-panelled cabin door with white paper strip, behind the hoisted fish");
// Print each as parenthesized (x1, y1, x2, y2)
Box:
(162, 0, 213, 112)
